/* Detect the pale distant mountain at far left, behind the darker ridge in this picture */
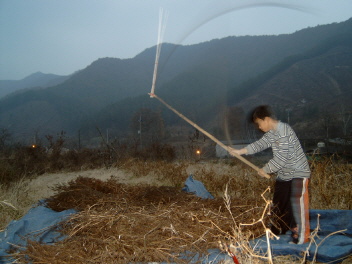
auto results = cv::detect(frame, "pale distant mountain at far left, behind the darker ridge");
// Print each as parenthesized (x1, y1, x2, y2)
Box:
(0, 72, 69, 98)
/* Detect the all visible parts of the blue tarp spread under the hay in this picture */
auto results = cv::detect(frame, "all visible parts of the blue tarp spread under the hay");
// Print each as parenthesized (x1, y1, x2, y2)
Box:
(0, 175, 352, 264)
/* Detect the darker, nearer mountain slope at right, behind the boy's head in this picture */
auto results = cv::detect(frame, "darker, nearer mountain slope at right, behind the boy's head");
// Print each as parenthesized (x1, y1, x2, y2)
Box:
(236, 43, 352, 138)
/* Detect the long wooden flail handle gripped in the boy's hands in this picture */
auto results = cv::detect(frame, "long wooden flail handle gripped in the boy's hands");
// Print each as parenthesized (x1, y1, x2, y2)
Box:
(149, 93, 270, 179)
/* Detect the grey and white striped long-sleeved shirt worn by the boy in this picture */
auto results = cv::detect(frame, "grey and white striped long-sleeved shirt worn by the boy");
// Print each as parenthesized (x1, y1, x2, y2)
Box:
(246, 121, 310, 181)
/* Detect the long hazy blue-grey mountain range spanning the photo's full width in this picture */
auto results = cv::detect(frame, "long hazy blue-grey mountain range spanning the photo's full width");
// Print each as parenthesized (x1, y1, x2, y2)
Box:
(0, 19, 352, 146)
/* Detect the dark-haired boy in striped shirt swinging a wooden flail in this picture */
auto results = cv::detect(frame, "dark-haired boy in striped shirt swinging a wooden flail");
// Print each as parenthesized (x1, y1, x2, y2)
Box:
(228, 105, 310, 244)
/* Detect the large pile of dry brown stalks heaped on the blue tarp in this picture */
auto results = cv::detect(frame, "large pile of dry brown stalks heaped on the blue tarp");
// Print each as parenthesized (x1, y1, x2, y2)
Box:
(14, 177, 264, 263)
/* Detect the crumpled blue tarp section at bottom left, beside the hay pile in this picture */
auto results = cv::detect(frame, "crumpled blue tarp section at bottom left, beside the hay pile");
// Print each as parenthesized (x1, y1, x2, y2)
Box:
(0, 204, 76, 264)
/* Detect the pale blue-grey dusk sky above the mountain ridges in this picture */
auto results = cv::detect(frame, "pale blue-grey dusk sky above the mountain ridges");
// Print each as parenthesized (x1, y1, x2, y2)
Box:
(0, 0, 352, 80)
